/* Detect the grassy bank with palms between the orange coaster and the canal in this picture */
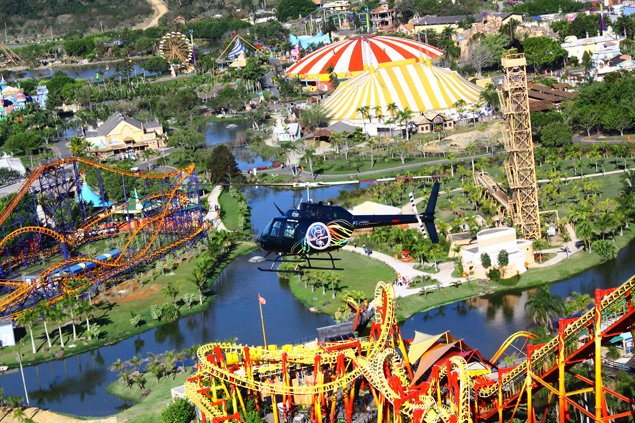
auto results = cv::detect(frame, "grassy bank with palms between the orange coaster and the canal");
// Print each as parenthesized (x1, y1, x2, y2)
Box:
(0, 242, 257, 368)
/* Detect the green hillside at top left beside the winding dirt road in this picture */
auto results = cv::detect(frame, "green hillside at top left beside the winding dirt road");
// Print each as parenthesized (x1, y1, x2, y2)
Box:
(0, 0, 153, 41)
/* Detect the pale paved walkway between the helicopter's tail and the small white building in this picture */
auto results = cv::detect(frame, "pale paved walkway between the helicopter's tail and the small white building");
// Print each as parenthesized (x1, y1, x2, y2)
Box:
(344, 245, 467, 297)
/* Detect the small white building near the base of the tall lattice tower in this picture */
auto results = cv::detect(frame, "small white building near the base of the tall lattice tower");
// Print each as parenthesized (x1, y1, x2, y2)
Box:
(461, 228, 534, 278)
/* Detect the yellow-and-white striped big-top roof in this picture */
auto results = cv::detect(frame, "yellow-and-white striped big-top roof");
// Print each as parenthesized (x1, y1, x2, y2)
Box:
(322, 59, 483, 120)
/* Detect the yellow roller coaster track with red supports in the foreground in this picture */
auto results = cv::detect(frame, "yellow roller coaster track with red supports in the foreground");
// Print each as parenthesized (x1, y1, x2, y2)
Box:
(185, 276, 635, 423)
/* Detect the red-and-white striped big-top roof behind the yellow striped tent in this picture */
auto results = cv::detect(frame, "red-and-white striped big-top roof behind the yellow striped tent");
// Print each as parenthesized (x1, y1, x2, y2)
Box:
(286, 35, 443, 81)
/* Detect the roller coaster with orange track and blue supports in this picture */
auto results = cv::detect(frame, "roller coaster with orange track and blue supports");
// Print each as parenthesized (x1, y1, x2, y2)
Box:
(0, 157, 203, 318)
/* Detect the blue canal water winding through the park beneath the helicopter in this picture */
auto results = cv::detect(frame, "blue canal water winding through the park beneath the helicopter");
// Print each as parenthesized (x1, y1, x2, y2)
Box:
(0, 178, 635, 416)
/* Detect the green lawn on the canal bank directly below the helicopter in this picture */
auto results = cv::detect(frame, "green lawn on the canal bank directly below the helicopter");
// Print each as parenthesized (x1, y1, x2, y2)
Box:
(289, 251, 397, 316)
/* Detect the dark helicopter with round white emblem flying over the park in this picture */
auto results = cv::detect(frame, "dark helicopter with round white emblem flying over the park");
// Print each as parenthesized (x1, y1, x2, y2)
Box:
(256, 180, 440, 274)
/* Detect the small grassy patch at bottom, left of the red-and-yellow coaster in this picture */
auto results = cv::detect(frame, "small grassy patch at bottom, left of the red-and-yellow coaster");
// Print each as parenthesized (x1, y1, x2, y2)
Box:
(106, 373, 190, 423)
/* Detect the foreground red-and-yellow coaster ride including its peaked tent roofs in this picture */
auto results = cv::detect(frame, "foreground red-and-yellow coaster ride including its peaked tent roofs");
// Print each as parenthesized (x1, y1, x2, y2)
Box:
(185, 277, 635, 423)
